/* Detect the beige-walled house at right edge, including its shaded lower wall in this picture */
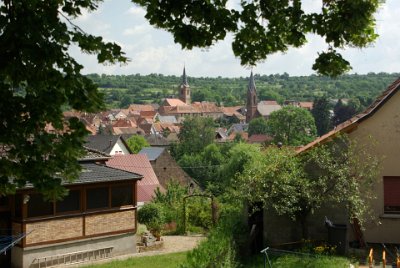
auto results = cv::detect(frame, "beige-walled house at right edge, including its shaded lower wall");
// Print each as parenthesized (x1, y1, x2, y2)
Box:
(262, 79, 400, 251)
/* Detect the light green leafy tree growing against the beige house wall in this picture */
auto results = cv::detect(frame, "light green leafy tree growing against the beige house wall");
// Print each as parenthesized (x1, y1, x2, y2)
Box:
(235, 139, 379, 238)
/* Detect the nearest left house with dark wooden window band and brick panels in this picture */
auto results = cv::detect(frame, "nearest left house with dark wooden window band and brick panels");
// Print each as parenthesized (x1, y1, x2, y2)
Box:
(2, 149, 142, 268)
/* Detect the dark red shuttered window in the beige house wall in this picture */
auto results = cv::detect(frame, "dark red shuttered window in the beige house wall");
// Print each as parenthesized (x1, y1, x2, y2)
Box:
(383, 177, 400, 214)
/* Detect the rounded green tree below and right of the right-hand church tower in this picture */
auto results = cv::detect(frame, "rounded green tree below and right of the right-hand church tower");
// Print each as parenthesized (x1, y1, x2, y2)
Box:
(267, 105, 316, 145)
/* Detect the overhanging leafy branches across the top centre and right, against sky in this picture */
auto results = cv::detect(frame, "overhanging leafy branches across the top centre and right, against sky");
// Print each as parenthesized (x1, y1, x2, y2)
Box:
(133, 0, 382, 76)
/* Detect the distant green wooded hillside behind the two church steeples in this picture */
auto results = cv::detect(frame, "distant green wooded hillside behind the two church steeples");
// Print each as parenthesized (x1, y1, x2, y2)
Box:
(88, 73, 400, 108)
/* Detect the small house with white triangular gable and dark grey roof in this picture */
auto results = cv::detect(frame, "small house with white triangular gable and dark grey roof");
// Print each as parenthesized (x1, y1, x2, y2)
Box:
(86, 135, 132, 155)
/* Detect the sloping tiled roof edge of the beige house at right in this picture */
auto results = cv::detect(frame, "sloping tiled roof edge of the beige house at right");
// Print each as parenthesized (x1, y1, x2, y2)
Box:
(297, 78, 400, 153)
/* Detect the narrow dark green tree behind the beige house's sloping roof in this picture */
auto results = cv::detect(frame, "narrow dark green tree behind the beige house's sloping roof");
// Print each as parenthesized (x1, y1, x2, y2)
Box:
(311, 96, 331, 136)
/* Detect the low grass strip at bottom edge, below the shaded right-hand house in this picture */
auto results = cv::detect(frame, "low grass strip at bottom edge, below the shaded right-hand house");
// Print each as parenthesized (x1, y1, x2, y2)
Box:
(243, 254, 350, 268)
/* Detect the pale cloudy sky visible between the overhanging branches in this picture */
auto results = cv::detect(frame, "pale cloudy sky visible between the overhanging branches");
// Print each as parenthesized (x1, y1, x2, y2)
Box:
(70, 0, 400, 77)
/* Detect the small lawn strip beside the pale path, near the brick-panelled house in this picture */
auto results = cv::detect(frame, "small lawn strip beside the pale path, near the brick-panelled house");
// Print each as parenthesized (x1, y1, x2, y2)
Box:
(85, 252, 187, 268)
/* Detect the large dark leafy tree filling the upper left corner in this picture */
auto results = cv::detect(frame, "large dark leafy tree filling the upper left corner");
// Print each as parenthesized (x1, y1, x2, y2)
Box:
(0, 0, 127, 199)
